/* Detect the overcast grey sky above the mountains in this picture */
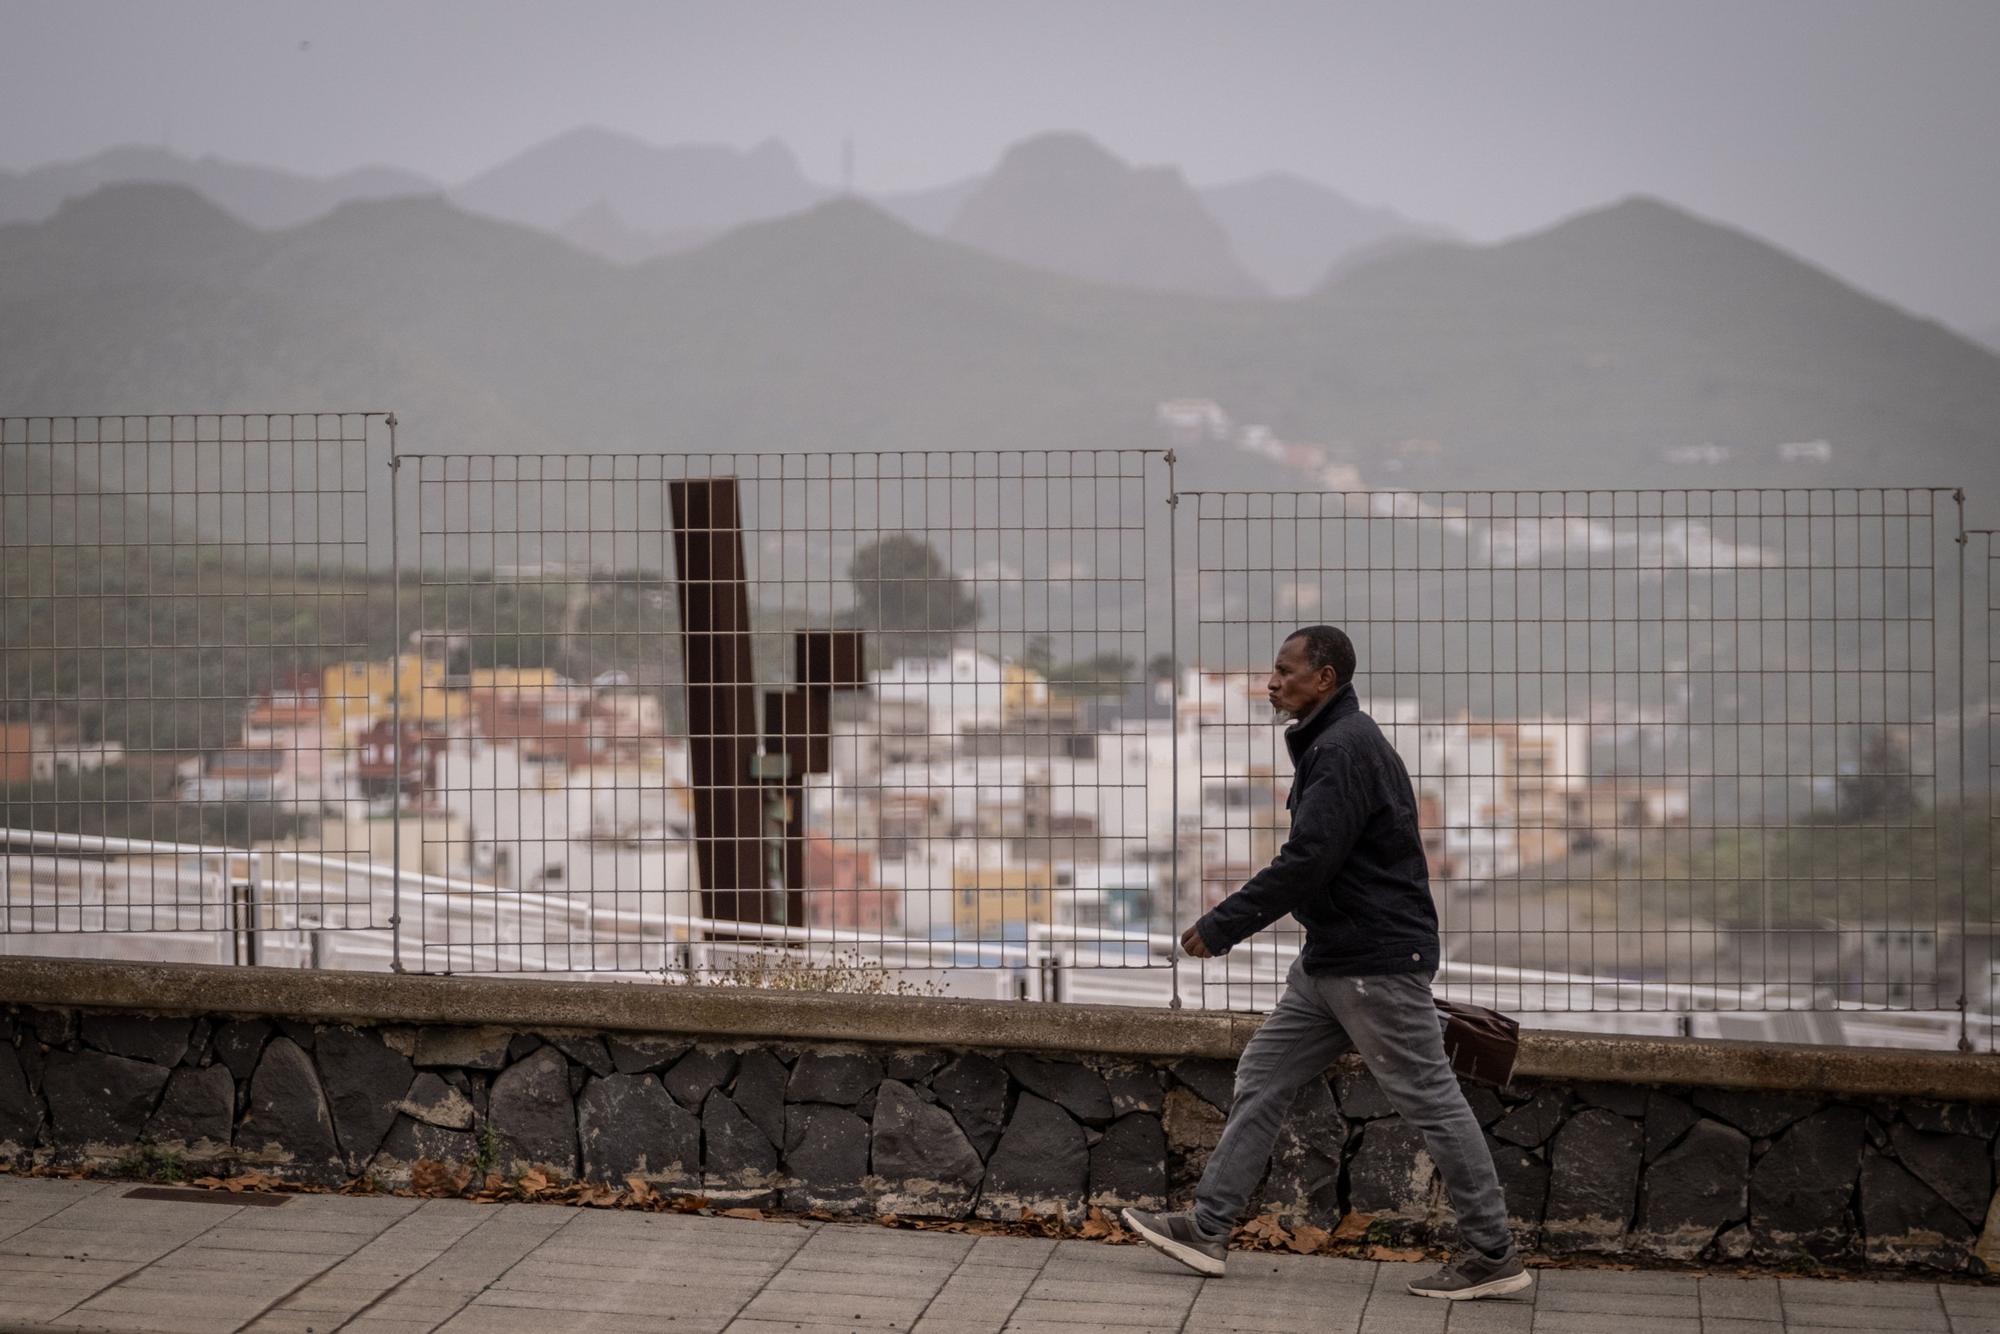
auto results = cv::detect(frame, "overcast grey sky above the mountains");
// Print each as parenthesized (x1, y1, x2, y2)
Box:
(0, 0, 2000, 328)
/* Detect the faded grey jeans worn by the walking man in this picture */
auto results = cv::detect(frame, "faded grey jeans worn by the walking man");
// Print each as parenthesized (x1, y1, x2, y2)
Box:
(1194, 964, 1514, 1254)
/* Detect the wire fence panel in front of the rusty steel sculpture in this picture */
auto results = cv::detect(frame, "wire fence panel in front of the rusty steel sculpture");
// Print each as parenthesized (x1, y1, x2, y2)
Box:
(396, 452, 1172, 972)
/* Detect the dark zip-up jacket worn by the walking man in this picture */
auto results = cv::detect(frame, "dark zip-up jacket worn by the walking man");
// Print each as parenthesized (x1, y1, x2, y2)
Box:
(1194, 684, 1438, 976)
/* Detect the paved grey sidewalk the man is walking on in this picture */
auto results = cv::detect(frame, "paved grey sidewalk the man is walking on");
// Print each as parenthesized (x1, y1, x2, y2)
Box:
(0, 1176, 2000, 1334)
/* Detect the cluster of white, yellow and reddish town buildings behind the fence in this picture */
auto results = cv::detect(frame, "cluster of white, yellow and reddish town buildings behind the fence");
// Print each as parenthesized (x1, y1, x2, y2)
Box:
(0, 636, 1690, 964)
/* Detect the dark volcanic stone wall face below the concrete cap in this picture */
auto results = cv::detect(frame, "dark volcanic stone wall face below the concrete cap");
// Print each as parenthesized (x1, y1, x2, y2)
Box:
(0, 1006, 2000, 1270)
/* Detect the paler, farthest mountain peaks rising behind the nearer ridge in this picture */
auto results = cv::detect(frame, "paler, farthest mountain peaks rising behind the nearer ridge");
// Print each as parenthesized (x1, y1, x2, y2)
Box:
(0, 128, 1442, 296)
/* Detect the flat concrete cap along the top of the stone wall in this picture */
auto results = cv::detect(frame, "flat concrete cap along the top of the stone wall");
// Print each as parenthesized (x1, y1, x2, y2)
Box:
(0, 958, 2000, 1102)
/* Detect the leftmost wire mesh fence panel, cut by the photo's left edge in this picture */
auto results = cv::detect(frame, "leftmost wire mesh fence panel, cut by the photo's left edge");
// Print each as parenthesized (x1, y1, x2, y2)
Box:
(0, 412, 394, 962)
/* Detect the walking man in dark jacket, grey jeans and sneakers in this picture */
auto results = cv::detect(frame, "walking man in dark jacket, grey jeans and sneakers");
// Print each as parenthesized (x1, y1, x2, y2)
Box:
(1124, 626, 1532, 1300)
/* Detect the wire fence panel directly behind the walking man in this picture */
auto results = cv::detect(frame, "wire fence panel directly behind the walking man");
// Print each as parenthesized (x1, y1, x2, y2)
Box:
(1182, 490, 1988, 1036)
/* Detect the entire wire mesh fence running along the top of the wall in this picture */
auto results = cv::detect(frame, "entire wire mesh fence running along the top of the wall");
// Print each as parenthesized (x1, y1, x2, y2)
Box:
(0, 414, 2000, 1046)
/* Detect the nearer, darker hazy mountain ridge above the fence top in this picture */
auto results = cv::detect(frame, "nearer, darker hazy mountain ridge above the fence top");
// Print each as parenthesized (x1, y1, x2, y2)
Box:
(11, 171, 2000, 514)
